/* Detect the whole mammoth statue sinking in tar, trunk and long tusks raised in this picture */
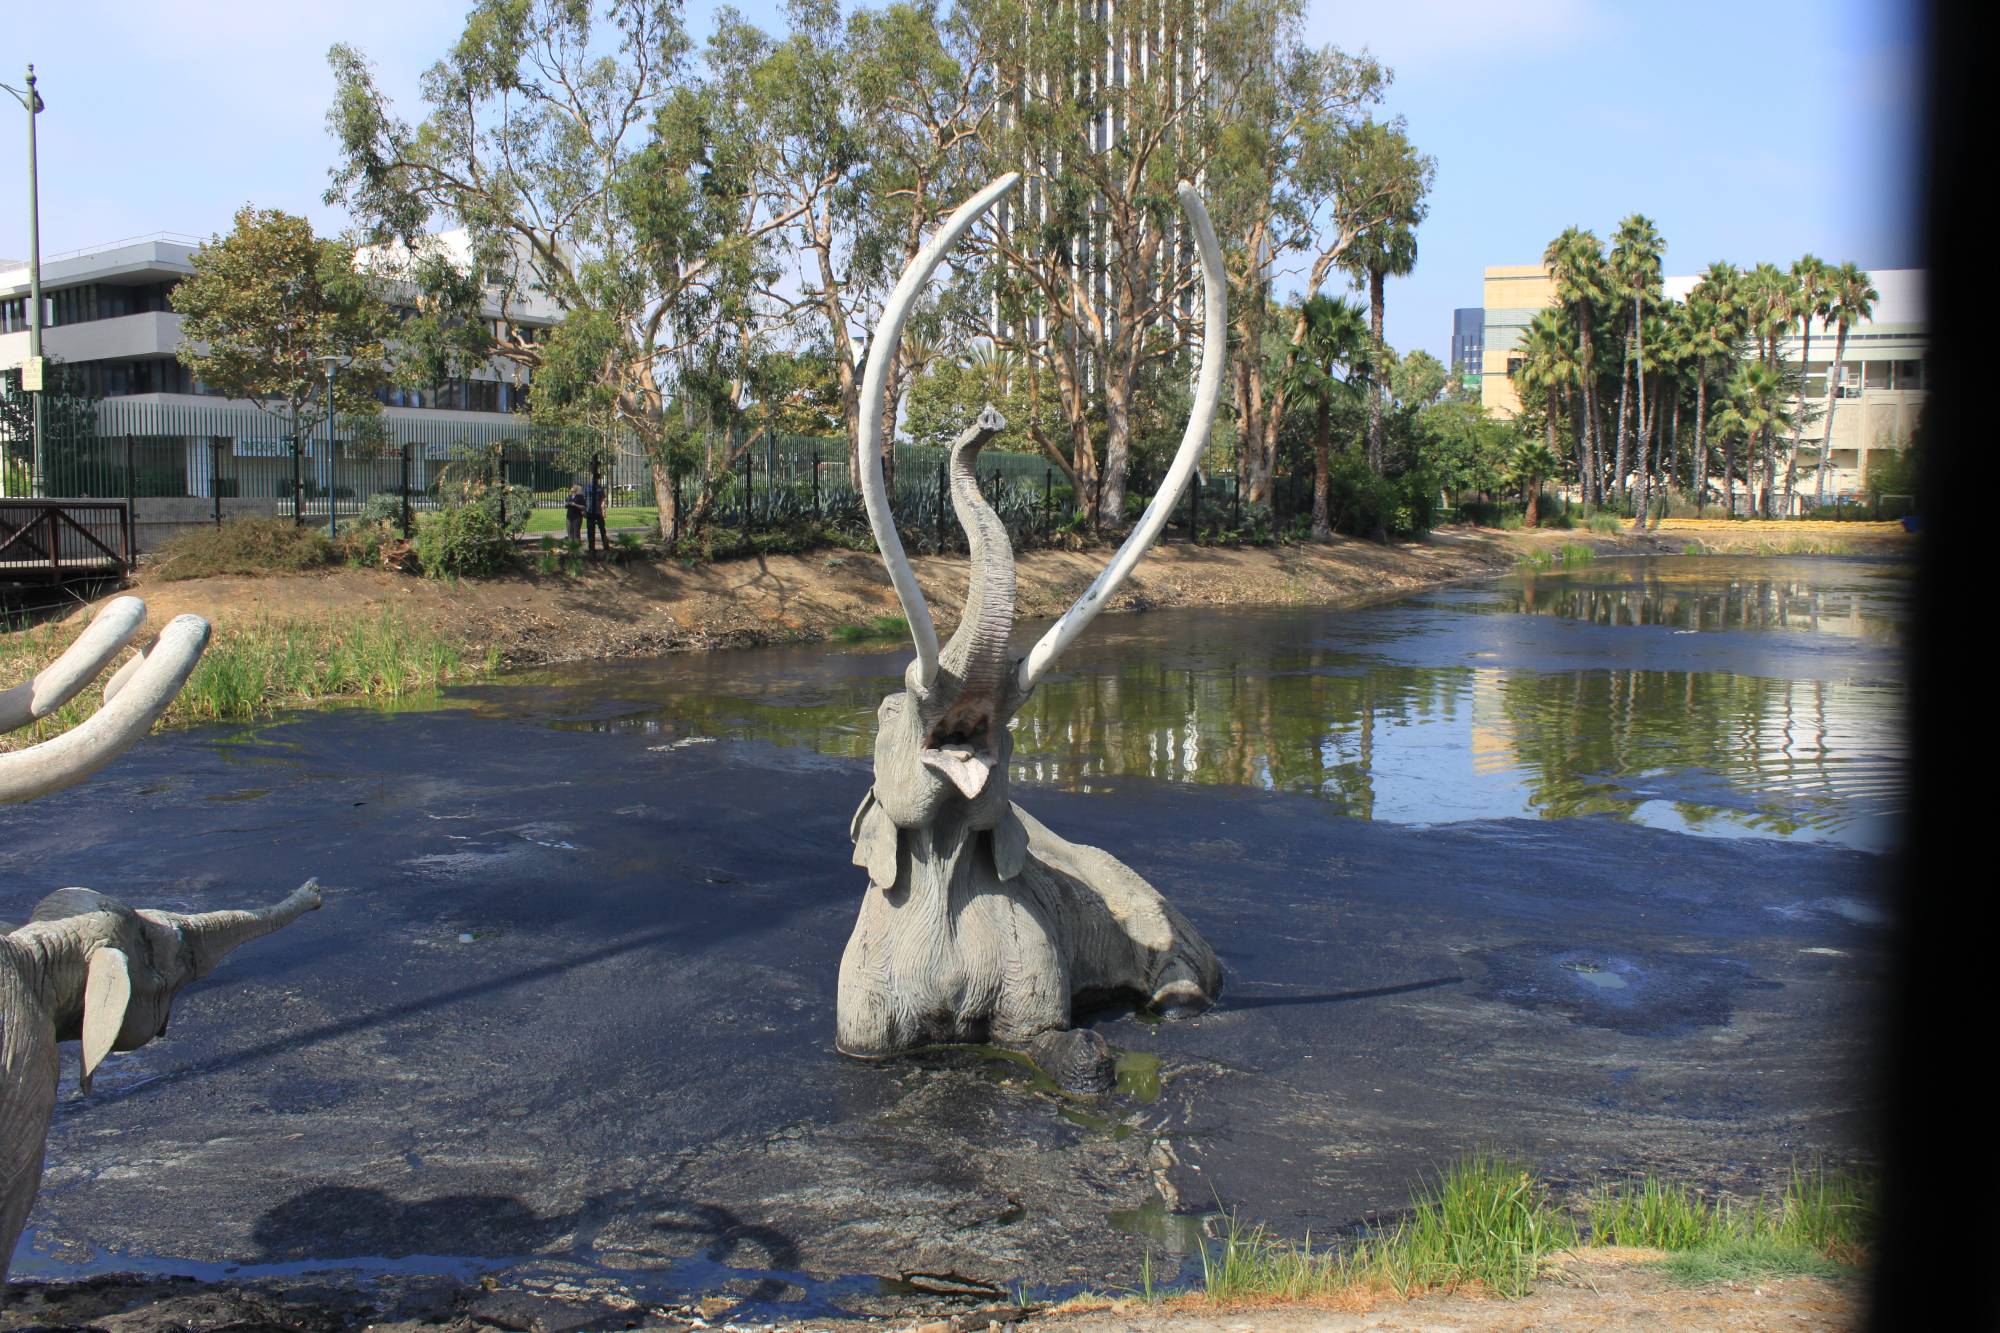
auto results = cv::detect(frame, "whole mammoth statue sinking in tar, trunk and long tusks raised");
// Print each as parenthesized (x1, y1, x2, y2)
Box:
(836, 174, 1228, 1091)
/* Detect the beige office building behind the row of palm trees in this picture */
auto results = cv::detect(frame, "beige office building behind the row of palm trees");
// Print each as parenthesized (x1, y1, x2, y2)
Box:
(1480, 264, 1928, 502)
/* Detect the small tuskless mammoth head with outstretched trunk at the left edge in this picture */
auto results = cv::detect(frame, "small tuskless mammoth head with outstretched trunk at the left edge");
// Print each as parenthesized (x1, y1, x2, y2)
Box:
(24, 881, 320, 1093)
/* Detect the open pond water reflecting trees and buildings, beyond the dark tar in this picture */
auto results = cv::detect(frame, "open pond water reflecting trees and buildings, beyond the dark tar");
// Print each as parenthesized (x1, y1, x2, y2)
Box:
(508, 600, 1902, 833)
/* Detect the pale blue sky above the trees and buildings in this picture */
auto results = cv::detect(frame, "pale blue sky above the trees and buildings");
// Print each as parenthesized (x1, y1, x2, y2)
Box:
(0, 0, 1922, 356)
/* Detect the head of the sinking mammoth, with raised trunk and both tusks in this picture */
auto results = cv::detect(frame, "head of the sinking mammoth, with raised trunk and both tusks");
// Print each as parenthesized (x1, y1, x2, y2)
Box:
(856, 174, 1228, 839)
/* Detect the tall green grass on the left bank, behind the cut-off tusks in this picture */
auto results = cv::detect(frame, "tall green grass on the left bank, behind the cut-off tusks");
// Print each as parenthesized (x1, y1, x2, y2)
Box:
(0, 610, 500, 749)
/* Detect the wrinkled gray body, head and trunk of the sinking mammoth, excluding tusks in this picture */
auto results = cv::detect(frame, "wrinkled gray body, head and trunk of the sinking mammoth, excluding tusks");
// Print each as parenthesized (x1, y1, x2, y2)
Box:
(836, 420, 1222, 1064)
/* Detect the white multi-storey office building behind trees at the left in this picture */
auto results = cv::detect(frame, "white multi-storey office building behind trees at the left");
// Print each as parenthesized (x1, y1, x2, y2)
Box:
(0, 230, 560, 514)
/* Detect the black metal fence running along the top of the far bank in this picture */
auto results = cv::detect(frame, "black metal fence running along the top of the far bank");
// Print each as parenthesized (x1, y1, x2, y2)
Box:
(0, 400, 1264, 548)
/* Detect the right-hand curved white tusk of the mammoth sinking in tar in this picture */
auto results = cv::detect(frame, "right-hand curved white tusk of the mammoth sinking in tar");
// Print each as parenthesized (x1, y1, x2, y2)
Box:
(1014, 182, 1230, 695)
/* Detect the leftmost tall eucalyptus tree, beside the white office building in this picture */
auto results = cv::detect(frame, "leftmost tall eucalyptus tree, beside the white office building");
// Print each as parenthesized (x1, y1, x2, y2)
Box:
(326, 0, 772, 532)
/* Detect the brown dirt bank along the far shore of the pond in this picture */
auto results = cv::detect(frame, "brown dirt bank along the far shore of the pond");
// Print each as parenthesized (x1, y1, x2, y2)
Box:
(66, 518, 1912, 664)
